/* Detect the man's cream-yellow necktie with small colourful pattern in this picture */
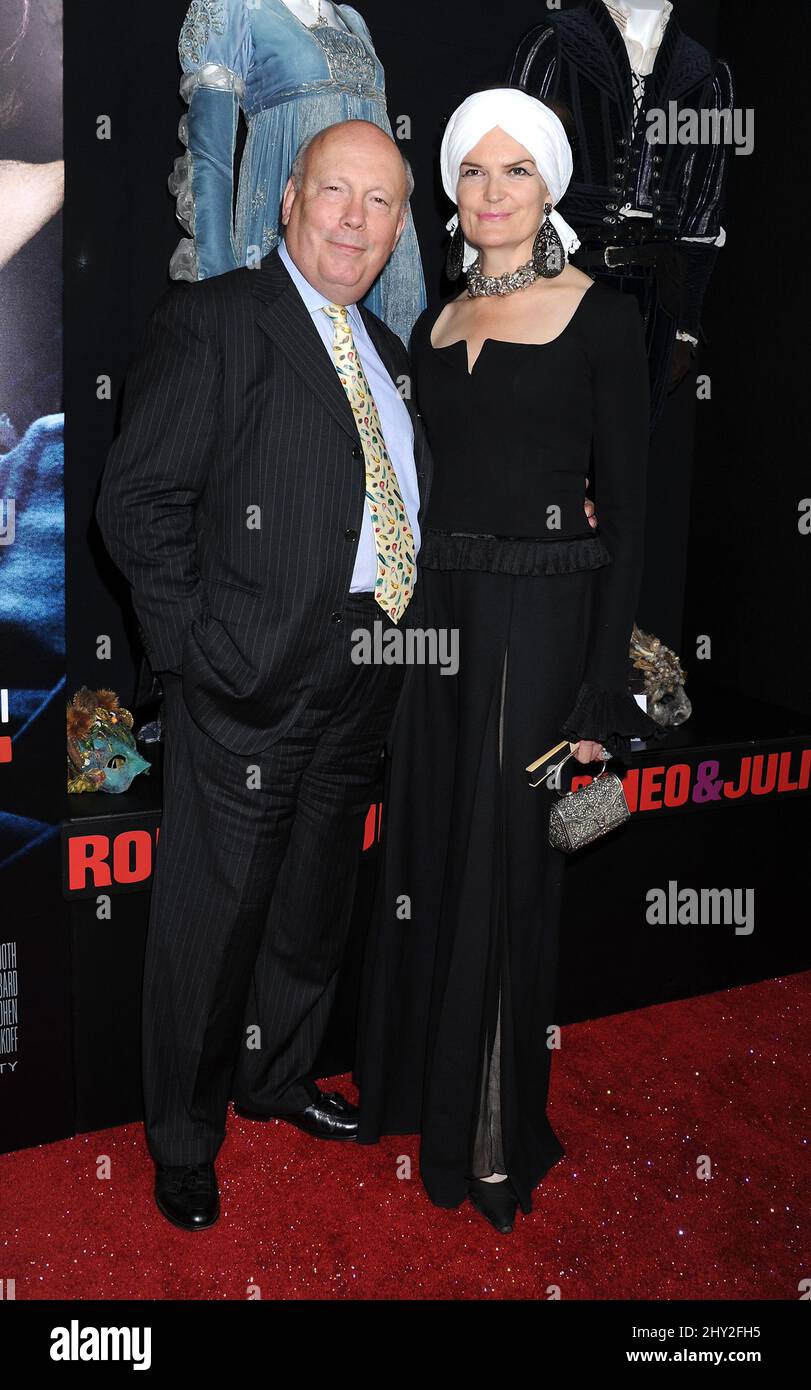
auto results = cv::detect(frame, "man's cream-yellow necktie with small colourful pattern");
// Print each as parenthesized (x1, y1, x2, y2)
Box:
(323, 304, 415, 623)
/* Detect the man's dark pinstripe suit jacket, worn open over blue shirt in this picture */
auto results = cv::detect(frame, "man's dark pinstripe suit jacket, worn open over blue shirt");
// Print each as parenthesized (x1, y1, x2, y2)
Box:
(96, 250, 433, 752)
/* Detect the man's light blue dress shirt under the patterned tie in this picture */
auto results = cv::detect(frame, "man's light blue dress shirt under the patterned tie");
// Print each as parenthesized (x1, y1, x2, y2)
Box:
(278, 239, 420, 594)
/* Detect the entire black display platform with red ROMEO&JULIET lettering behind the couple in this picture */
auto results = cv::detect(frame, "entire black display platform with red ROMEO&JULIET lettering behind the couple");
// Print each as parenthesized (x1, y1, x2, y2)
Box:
(64, 681, 811, 1131)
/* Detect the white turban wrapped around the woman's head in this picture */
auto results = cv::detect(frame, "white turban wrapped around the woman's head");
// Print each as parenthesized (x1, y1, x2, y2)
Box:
(440, 88, 580, 270)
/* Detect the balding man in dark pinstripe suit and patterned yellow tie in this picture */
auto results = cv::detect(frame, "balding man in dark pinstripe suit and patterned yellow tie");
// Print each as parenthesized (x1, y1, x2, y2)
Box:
(96, 121, 431, 1230)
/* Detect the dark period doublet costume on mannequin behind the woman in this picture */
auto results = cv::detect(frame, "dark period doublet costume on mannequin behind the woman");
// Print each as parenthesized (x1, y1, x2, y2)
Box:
(508, 0, 733, 428)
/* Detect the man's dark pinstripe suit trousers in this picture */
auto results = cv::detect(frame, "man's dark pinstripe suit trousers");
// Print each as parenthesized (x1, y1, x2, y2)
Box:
(143, 595, 403, 1163)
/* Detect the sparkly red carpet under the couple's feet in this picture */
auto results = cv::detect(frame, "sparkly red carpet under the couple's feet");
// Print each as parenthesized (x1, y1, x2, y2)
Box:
(0, 974, 811, 1300)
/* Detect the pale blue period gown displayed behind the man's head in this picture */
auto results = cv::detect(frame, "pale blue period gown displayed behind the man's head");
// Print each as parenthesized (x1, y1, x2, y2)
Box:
(170, 0, 426, 343)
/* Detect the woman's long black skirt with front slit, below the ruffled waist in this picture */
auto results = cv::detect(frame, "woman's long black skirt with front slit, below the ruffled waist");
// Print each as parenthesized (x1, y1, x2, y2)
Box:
(355, 531, 607, 1212)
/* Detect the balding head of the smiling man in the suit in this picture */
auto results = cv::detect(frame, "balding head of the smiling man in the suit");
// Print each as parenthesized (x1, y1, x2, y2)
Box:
(281, 121, 413, 304)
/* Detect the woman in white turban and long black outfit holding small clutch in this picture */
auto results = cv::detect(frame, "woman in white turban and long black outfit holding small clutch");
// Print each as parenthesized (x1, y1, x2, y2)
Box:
(356, 89, 657, 1232)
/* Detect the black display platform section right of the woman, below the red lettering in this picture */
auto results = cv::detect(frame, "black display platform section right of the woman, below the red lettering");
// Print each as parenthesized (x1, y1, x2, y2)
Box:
(558, 680, 811, 1024)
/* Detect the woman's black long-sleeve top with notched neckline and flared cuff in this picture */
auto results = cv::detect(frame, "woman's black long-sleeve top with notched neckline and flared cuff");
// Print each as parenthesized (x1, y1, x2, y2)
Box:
(410, 282, 658, 762)
